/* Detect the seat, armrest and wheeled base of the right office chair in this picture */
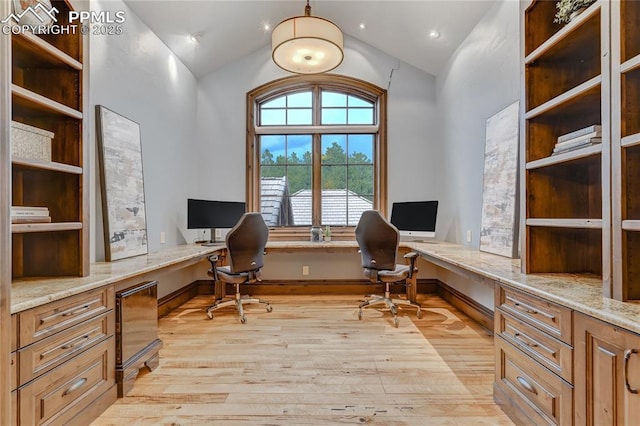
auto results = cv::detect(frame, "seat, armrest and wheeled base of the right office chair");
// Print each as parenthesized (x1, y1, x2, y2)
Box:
(358, 253, 422, 328)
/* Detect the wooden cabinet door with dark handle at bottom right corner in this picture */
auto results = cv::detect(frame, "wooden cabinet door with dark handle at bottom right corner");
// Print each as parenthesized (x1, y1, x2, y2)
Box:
(574, 314, 640, 426)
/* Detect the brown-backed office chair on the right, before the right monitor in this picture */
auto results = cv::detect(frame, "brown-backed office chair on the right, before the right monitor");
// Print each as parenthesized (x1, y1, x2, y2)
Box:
(356, 210, 422, 327)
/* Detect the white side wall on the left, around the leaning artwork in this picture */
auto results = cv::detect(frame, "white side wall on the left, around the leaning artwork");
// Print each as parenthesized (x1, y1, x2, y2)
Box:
(89, 0, 199, 261)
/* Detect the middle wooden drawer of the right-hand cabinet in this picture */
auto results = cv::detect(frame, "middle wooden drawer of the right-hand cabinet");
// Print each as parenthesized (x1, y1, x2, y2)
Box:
(495, 309, 573, 383)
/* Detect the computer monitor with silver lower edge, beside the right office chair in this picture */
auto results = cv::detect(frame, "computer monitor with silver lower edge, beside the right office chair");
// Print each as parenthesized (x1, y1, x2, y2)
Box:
(391, 201, 438, 240)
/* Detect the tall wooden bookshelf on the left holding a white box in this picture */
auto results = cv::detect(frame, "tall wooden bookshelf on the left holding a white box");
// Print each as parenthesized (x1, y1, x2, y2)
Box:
(6, 0, 89, 279)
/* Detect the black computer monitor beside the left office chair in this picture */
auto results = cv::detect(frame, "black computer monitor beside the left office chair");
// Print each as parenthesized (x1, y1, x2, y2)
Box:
(187, 198, 246, 243)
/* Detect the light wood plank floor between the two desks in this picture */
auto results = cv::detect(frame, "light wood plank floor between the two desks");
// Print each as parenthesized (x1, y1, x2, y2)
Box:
(93, 295, 513, 426)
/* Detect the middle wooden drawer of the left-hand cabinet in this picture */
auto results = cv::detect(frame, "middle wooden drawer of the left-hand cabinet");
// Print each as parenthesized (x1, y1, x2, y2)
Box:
(18, 311, 115, 385)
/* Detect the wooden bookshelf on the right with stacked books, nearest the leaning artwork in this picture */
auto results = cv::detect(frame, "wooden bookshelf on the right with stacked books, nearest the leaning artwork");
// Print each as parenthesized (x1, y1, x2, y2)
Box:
(521, 1, 611, 282)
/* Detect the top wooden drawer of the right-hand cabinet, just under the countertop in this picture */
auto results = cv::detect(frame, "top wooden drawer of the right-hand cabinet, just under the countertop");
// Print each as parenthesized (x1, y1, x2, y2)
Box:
(496, 286, 573, 345)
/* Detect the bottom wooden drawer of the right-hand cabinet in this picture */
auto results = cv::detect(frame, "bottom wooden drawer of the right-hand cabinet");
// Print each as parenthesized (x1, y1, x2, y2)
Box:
(495, 337, 573, 425)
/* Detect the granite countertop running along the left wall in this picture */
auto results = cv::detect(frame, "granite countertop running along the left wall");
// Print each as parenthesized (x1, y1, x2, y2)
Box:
(11, 244, 224, 314)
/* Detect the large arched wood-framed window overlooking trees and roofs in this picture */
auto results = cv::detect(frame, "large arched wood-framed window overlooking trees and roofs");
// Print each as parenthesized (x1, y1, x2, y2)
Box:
(247, 75, 386, 236)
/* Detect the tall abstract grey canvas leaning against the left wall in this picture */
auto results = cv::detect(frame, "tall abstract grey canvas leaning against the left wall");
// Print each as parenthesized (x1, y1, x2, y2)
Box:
(96, 105, 148, 261)
